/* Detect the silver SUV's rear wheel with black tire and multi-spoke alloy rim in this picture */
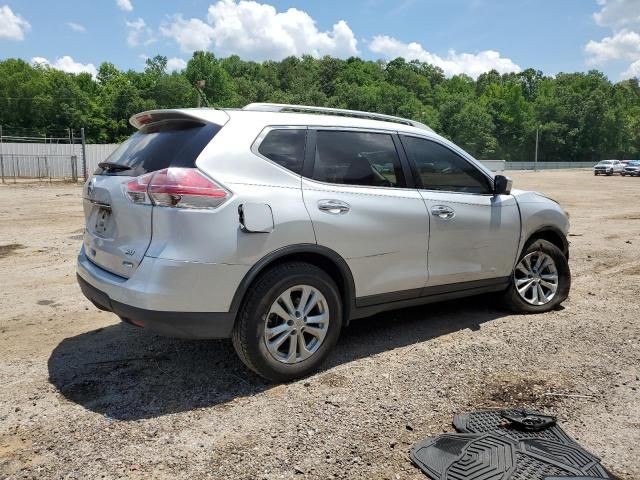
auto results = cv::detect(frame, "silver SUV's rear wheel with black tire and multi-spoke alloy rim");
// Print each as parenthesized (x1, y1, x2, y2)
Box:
(232, 262, 342, 382)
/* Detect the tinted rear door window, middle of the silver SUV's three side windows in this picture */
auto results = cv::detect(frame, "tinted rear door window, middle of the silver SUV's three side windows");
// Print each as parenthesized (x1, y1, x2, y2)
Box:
(313, 130, 405, 187)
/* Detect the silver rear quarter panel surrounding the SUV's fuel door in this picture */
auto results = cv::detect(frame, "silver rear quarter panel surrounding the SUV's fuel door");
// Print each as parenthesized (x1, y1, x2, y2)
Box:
(147, 115, 316, 265)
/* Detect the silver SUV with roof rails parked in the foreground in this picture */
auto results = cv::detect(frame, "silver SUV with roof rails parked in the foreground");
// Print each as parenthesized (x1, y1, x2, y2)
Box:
(77, 104, 571, 381)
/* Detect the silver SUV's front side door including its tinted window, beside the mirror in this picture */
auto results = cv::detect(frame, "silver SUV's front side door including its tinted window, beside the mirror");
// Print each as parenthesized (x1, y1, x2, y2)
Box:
(401, 136, 520, 286)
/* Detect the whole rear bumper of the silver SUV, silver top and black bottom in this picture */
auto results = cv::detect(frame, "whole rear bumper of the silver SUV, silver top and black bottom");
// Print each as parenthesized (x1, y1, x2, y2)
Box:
(77, 248, 250, 339)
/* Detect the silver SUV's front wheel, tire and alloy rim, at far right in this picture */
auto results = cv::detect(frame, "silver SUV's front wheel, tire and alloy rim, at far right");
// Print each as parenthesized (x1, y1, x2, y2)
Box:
(504, 240, 571, 313)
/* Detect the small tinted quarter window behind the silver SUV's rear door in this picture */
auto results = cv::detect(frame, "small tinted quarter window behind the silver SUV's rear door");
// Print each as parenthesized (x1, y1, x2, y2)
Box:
(258, 128, 307, 175)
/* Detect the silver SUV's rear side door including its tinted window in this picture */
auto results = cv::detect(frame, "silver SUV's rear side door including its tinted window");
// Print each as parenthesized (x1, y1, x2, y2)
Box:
(302, 128, 429, 305)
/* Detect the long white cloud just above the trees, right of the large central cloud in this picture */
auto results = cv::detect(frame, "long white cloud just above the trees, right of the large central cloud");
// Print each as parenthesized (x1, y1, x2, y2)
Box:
(369, 35, 522, 78)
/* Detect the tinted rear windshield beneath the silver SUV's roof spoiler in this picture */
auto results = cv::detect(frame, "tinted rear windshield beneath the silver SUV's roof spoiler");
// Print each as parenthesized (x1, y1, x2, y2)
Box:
(95, 119, 221, 176)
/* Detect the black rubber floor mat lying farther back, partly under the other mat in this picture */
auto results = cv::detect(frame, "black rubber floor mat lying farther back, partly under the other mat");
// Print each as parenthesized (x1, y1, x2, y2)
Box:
(453, 409, 575, 444)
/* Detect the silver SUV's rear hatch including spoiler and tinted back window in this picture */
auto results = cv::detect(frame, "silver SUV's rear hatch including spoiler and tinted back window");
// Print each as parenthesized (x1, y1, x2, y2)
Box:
(83, 111, 221, 278)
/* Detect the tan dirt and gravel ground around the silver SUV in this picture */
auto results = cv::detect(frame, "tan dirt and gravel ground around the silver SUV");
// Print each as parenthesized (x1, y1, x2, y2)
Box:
(0, 171, 640, 480)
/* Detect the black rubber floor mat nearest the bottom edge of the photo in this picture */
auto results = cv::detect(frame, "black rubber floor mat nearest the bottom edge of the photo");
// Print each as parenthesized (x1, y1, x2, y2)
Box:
(411, 433, 612, 480)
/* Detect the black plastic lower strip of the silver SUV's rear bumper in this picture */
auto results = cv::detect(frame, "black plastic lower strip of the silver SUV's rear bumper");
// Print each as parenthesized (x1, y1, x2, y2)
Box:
(76, 275, 235, 339)
